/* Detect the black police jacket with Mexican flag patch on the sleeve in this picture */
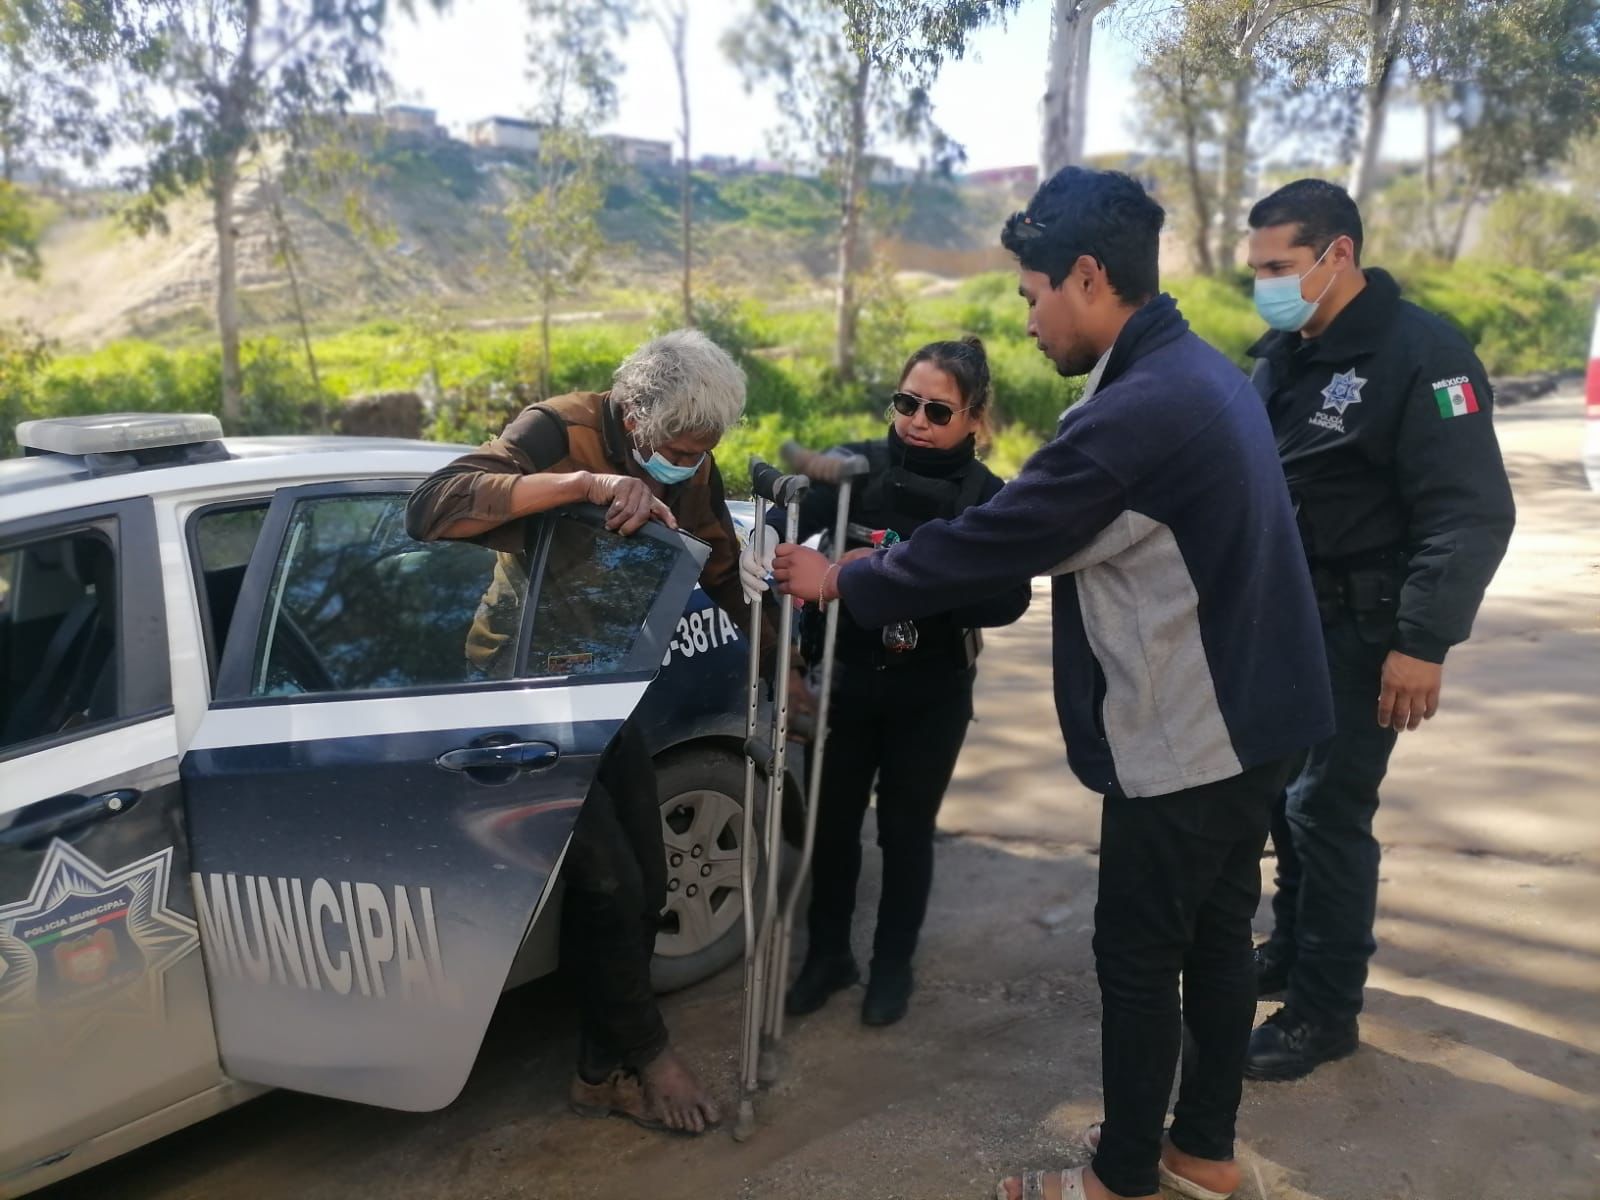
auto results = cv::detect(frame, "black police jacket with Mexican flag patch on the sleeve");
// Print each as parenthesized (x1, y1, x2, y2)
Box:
(1250, 269, 1515, 662)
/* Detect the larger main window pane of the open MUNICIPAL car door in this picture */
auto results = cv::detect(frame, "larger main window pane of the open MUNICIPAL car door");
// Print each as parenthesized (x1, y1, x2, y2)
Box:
(251, 493, 528, 696)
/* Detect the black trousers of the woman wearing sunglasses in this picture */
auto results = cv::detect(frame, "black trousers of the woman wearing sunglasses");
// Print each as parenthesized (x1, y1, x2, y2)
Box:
(810, 664, 974, 962)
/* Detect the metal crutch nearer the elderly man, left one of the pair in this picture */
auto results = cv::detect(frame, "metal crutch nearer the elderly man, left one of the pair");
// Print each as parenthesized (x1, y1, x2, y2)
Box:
(733, 458, 810, 1141)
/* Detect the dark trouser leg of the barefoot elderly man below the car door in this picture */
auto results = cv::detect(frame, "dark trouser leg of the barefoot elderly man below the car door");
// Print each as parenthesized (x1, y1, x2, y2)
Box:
(562, 723, 667, 1083)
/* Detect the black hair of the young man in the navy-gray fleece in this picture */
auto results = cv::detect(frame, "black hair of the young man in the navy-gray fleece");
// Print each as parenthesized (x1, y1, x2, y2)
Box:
(1000, 166, 1166, 304)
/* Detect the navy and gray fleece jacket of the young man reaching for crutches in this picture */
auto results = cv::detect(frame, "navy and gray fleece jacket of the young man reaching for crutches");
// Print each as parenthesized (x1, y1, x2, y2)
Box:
(838, 296, 1337, 797)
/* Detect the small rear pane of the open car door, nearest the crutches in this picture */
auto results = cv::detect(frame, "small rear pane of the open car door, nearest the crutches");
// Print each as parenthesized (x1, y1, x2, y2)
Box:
(528, 517, 678, 675)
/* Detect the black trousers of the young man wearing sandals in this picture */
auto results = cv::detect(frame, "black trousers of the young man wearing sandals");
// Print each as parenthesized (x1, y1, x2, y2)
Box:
(1094, 760, 1290, 1195)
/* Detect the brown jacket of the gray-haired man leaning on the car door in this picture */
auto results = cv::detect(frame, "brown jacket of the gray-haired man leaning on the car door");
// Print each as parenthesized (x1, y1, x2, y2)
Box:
(406, 392, 771, 645)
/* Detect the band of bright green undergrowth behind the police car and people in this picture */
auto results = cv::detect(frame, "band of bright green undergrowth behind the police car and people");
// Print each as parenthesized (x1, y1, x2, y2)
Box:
(9, 256, 1600, 473)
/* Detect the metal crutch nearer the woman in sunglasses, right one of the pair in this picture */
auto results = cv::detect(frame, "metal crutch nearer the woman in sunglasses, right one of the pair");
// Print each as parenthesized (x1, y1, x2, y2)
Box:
(760, 442, 870, 1083)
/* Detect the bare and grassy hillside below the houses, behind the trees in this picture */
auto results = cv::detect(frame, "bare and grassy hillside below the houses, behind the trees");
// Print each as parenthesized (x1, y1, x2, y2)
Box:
(0, 136, 1013, 347)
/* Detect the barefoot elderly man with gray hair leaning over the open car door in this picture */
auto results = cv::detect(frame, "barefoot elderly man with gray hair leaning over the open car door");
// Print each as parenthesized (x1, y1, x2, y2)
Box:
(406, 330, 764, 1133)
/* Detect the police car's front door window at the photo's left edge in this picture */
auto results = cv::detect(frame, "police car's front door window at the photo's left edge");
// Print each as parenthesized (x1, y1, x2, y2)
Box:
(0, 530, 118, 749)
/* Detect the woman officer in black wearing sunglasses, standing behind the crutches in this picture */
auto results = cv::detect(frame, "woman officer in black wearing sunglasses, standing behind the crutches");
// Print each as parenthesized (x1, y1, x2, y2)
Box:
(739, 338, 1029, 1026)
